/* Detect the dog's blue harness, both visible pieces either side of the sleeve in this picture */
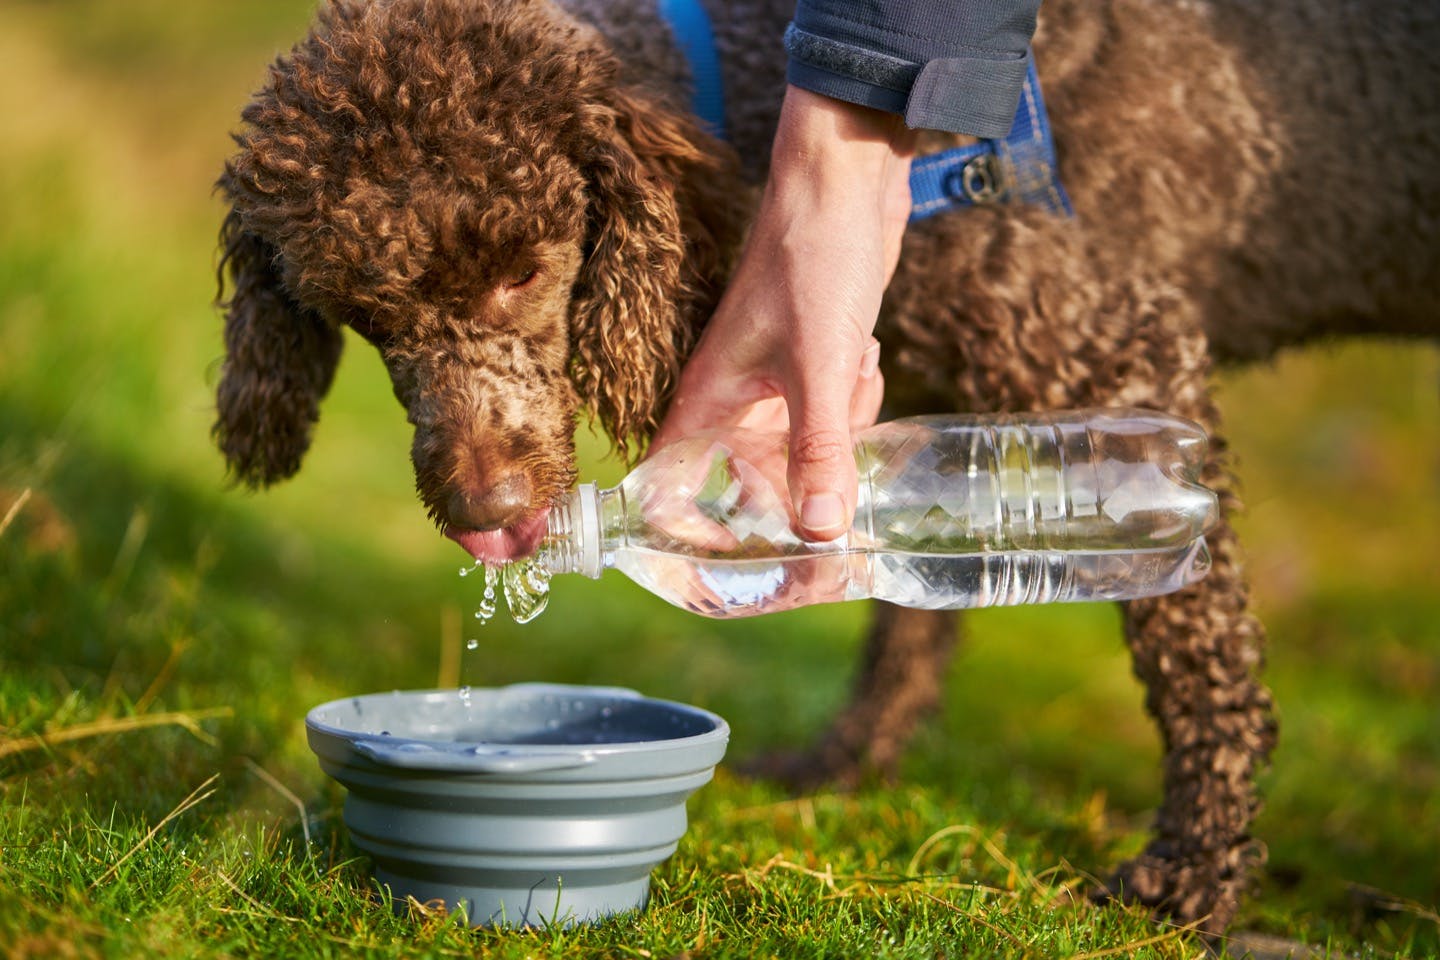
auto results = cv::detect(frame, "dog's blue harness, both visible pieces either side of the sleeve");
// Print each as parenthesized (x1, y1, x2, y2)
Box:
(657, 0, 1074, 223)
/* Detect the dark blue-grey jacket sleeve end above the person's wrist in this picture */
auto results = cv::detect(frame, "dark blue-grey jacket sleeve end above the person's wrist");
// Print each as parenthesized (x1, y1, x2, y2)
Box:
(785, 0, 1040, 138)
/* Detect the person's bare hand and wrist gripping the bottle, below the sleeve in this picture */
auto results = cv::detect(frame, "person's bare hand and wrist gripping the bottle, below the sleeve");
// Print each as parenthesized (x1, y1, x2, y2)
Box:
(652, 86, 914, 540)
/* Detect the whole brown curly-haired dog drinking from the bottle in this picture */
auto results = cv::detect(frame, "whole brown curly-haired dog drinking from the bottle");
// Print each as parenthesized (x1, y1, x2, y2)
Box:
(215, 0, 1440, 931)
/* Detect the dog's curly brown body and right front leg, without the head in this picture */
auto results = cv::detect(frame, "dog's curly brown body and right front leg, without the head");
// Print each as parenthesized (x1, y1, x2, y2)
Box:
(848, 0, 1440, 931)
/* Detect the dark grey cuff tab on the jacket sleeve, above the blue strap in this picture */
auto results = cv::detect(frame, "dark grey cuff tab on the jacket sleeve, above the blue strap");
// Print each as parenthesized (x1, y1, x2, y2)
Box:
(904, 50, 1030, 140)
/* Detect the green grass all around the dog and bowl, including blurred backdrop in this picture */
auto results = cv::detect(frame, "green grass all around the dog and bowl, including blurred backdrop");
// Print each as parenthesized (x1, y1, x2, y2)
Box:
(0, 0, 1440, 957)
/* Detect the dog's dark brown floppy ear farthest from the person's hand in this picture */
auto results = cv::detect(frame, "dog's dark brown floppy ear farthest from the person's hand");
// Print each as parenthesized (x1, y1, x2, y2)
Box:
(212, 212, 344, 488)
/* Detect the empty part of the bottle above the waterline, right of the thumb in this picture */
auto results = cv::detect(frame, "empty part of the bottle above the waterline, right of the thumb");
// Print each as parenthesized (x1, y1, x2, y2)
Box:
(855, 410, 1218, 554)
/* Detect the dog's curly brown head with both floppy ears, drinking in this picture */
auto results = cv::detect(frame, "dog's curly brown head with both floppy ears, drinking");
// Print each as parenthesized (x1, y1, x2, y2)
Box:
(215, 0, 740, 561)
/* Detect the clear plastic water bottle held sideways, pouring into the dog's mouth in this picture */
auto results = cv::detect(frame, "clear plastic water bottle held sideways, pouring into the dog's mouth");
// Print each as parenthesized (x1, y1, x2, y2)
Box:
(540, 409, 1218, 617)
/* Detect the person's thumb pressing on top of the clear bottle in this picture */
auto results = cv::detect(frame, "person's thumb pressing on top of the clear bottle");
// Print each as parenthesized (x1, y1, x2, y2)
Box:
(786, 359, 857, 540)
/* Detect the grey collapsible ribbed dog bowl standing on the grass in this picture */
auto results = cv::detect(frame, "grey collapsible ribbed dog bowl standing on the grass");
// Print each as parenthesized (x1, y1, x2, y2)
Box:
(305, 684, 730, 927)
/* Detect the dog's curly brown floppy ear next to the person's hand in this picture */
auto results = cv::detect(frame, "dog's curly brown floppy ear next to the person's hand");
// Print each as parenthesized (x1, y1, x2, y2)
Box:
(572, 91, 713, 455)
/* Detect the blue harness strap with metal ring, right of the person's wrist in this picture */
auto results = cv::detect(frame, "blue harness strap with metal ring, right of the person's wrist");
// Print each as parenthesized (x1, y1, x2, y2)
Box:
(910, 58, 1074, 223)
